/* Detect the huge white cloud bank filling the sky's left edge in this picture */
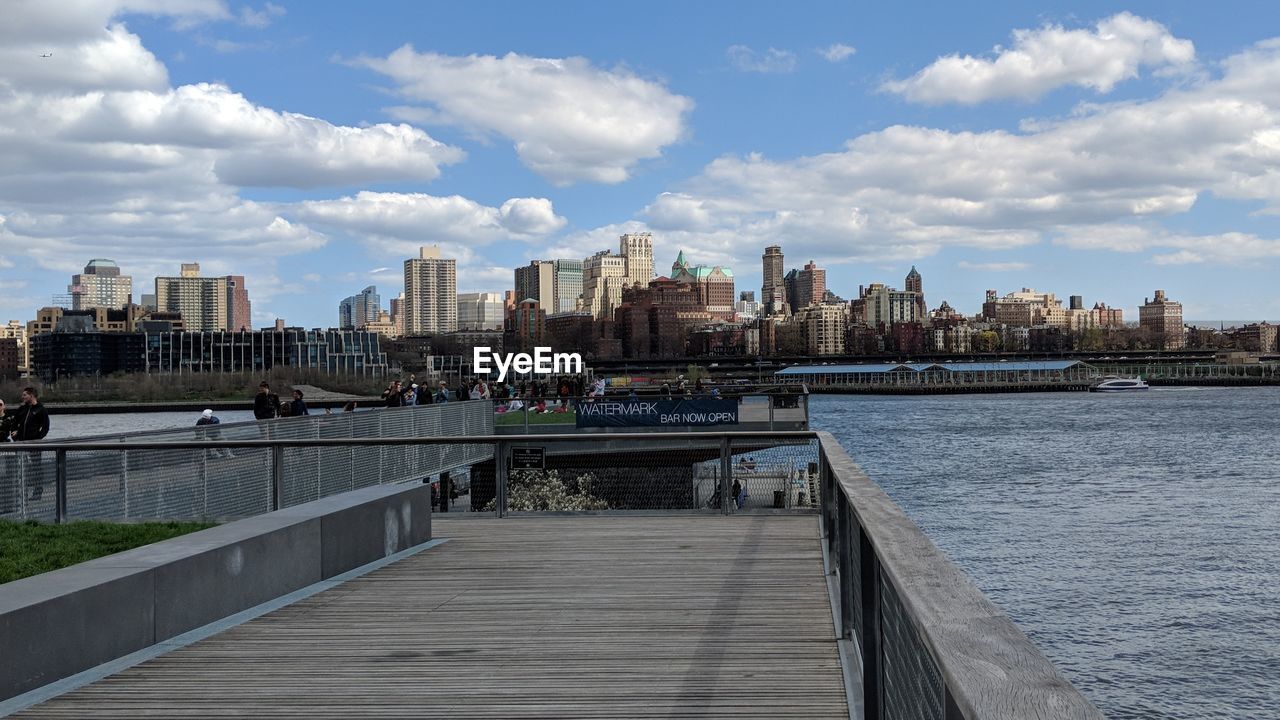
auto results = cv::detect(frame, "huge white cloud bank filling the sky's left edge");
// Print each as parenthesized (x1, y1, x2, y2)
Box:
(0, 0, 471, 316)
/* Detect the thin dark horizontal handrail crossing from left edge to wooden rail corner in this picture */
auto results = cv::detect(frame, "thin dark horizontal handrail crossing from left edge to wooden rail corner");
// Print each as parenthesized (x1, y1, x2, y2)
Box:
(0, 425, 818, 452)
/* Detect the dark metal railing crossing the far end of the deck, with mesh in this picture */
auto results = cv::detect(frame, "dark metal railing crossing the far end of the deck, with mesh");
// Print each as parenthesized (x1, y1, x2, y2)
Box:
(0, 425, 818, 523)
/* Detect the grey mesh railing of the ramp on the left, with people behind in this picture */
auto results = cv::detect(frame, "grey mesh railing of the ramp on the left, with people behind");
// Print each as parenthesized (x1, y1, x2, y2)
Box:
(0, 402, 493, 523)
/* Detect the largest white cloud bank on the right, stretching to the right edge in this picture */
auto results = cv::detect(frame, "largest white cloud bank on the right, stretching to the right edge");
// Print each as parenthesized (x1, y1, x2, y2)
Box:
(629, 41, 1280, 272)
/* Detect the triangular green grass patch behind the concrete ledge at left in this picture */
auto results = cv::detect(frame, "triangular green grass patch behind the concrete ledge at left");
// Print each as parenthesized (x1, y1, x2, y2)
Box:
(0, 520, 215, 583)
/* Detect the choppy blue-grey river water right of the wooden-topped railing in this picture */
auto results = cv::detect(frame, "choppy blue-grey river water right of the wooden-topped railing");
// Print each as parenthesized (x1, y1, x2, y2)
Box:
(810, 388, 1280, 719)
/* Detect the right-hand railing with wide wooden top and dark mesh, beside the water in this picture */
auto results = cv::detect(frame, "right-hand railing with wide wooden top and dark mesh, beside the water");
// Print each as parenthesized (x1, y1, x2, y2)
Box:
(818, 433, 1102, 720)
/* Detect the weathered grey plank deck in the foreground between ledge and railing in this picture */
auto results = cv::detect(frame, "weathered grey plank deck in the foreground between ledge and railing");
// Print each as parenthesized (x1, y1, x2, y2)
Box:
(18, 515, 849, 719)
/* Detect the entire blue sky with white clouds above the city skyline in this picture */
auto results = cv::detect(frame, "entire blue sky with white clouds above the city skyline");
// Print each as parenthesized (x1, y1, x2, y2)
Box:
(0, 0, 1280, 327)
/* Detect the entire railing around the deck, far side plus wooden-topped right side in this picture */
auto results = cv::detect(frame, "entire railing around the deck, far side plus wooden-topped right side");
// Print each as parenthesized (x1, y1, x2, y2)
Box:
(0, 420, 1102, 720)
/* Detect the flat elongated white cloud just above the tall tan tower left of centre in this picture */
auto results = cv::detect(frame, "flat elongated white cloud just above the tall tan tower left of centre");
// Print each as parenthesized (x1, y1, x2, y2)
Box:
(296, 191, 566, 248)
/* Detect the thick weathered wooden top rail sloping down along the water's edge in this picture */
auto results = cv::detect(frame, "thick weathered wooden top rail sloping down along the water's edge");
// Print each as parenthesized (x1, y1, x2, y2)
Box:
(817, 432, 1102, 720)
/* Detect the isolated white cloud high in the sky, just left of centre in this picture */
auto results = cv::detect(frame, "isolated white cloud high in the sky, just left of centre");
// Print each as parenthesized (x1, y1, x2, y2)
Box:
(356, 45, 694, 184)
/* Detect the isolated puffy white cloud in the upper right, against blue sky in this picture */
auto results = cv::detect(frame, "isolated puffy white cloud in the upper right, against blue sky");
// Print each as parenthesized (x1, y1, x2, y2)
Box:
(882, 13, 1196, 105)
